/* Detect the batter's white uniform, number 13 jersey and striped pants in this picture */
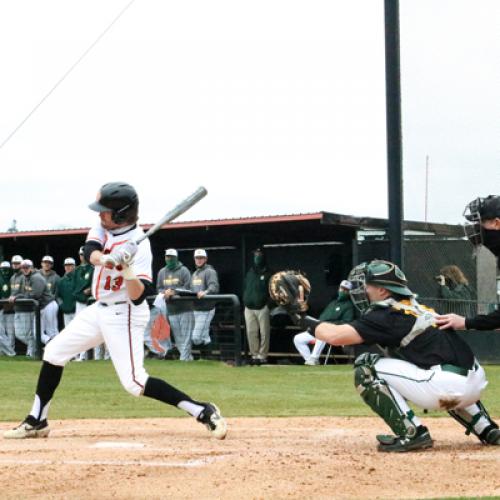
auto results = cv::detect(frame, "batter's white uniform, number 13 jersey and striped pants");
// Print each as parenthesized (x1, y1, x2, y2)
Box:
(43, 226, 152, 396)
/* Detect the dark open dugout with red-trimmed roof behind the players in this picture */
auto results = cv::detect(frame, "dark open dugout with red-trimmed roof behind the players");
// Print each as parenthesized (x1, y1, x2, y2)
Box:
(0, 212, 496, 364)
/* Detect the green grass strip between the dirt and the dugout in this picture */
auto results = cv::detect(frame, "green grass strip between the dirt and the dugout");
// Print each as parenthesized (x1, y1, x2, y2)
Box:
(0, 357, 500, 421)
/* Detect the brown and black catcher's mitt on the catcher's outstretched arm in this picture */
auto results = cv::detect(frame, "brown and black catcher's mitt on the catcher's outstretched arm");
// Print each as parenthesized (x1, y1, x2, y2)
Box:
(269, 271, 311, 314)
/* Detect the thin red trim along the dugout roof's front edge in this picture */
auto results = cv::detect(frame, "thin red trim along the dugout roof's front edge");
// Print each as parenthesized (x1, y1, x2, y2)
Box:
(0, 212, 323, 239)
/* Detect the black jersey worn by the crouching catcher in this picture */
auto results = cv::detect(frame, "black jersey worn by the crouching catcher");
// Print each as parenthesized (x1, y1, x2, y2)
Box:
(350, 307, 474, 370)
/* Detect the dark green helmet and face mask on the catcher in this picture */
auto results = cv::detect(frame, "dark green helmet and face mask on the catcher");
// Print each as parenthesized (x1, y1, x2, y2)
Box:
(348, 259, 413, 313)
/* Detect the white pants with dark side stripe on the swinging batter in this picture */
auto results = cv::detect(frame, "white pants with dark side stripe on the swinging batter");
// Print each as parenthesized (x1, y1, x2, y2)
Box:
(43, 301, 149, 396)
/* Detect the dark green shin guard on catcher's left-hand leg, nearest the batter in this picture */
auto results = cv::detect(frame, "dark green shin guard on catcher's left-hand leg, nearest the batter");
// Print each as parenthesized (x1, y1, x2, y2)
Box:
(354, 353, 417, 438)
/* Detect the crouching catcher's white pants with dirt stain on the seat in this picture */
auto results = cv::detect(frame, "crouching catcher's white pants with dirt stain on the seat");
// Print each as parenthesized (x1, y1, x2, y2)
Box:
(375, 358, 488, 412)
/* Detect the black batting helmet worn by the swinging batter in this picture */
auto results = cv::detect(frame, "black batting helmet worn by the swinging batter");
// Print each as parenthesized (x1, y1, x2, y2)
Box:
(89, 182, 139, 224)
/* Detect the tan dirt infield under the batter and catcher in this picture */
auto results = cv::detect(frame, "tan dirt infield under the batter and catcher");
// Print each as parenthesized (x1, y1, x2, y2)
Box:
(0, 417, 500, 499)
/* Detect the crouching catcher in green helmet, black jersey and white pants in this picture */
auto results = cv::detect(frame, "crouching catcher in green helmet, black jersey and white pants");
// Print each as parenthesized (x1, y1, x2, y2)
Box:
(269, 260, 500, 452)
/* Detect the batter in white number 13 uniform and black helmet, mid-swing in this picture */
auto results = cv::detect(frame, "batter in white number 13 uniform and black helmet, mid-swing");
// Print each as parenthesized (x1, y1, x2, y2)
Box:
(4, 182, 227, 439)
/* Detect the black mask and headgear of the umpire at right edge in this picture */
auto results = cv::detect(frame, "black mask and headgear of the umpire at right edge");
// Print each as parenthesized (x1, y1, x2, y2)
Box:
(463, 195, 500, 257)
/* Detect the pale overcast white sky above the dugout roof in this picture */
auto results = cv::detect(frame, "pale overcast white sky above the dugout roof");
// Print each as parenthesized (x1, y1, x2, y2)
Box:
(0, 0, 500, 232)
